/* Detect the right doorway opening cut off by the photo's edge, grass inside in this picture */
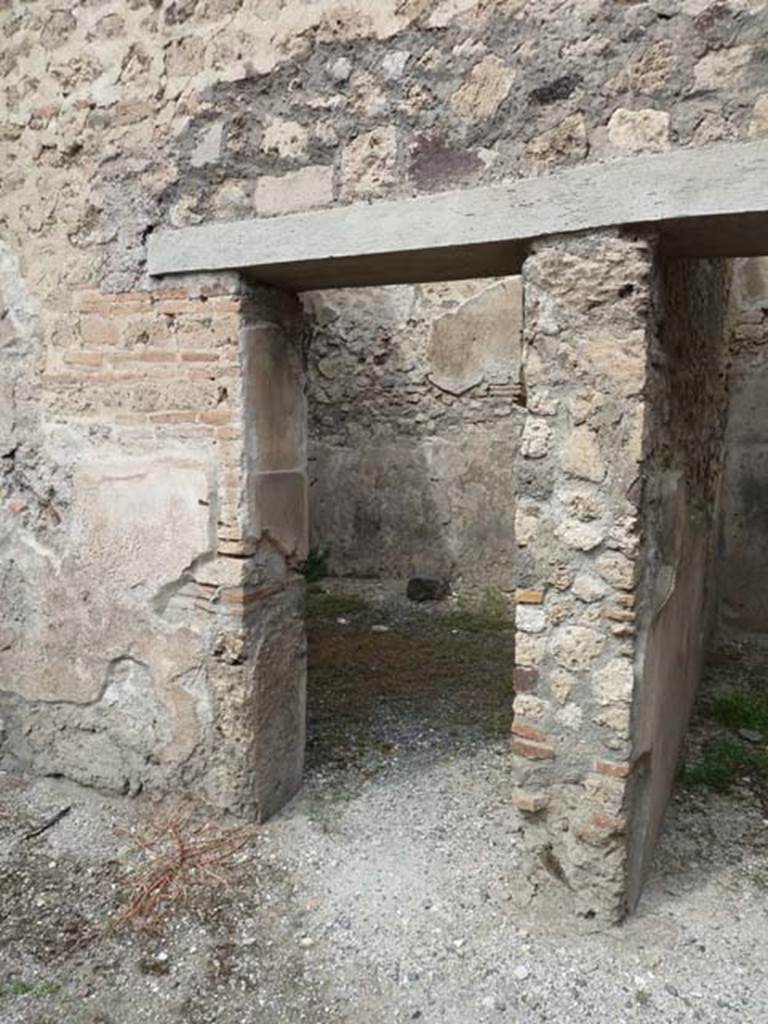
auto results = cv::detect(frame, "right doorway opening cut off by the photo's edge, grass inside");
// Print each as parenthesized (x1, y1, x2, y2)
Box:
(681, 257, 768, 818)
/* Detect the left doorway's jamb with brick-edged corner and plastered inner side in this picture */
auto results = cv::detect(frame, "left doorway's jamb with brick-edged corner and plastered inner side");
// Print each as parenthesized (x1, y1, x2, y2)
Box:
(212, 278, 308, 819)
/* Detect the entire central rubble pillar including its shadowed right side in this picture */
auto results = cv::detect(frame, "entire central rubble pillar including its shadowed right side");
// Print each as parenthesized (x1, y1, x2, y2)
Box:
(513, 232, 730, 920)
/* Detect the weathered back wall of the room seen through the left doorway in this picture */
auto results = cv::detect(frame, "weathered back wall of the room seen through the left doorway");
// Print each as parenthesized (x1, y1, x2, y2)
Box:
(304, 279, 521, 591)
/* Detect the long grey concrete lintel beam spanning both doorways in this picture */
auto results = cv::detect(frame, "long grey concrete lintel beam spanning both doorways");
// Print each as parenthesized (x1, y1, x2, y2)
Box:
(148, 141, 768, 291)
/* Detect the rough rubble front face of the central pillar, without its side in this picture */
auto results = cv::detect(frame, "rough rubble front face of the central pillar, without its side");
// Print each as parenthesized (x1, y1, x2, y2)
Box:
(513, 232, 652, 918)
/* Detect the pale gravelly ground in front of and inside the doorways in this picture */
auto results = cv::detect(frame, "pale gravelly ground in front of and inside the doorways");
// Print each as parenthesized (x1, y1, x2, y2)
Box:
(0, 585, 768, 1024)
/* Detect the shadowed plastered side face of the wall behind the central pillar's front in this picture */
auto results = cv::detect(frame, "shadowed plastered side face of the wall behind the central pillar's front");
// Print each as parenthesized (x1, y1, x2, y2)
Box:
(630, 253, 731, 905)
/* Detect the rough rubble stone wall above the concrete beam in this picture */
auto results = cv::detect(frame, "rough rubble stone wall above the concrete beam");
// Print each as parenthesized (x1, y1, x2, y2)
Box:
(0, 0, 768, 296)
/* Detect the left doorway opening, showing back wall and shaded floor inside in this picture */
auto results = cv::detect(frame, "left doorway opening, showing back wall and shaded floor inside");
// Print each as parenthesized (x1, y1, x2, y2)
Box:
(302, 278, 521, 786)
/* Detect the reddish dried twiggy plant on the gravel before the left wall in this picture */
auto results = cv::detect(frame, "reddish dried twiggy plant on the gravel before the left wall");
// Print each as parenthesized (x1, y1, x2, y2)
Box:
(118, 811, 254, 929)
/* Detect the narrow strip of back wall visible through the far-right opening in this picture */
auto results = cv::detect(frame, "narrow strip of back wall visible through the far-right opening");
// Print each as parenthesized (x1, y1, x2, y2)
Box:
(718, 259, 768, 638)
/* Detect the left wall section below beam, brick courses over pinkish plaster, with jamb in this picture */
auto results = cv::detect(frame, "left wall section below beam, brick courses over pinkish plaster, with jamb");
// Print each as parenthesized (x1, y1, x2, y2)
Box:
(0, 274, 307, 818)
